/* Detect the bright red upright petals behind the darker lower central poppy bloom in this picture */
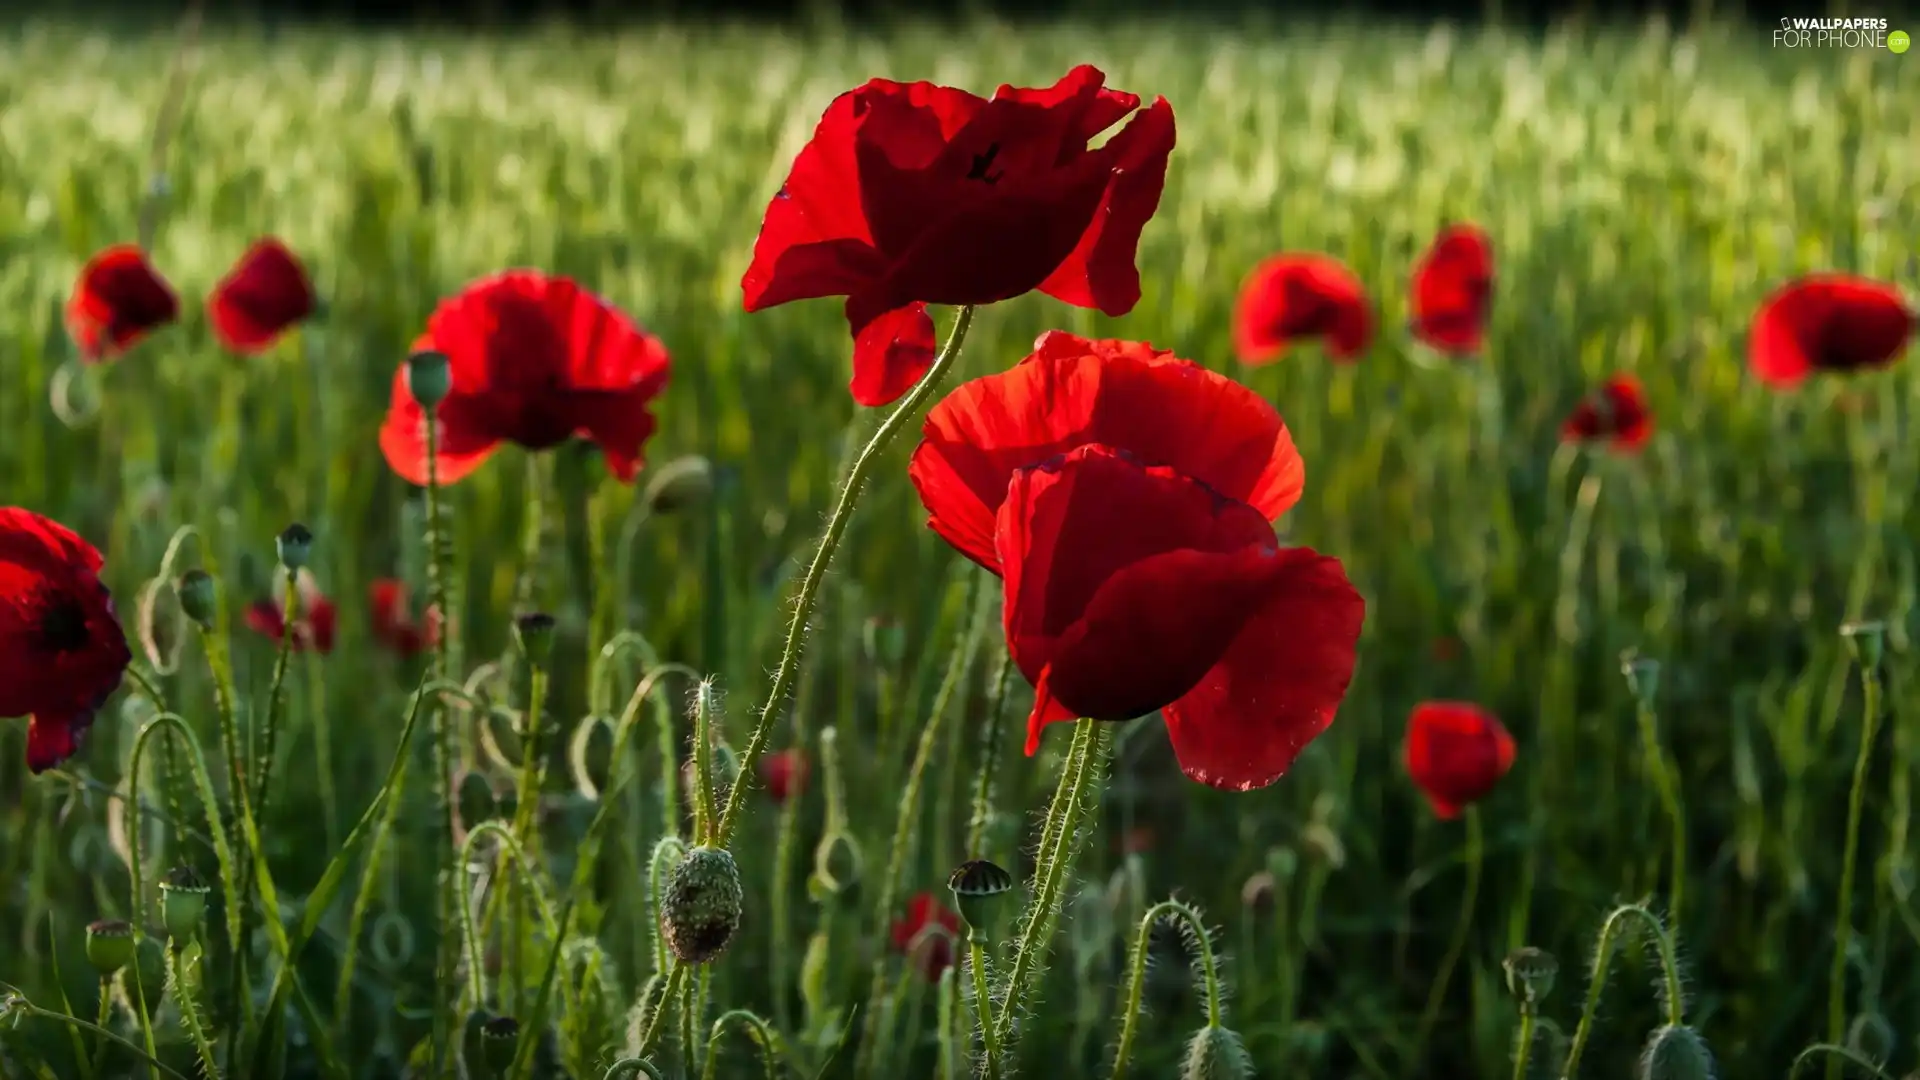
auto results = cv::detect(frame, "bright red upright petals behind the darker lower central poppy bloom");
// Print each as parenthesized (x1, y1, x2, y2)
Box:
(908, 331, 1306, 573)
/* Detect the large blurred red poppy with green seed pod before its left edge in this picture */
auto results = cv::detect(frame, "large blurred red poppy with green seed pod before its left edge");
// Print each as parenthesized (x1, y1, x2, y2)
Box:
(380, 271, 670, 484)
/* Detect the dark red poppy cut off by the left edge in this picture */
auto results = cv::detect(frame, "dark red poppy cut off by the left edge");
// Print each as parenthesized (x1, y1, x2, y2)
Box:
(0, 507, 132, 773)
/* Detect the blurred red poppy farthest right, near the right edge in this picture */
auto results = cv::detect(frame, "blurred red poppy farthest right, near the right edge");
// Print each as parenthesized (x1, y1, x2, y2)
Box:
(1747, 273, 1914, 390)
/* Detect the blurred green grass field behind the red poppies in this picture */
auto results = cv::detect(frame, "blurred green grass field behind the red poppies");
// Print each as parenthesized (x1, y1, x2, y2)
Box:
(0, 14, 1920, 1080)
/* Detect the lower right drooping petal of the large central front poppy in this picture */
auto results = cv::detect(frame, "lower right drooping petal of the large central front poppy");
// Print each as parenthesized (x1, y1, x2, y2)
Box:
(1164, 548, 1367, 792)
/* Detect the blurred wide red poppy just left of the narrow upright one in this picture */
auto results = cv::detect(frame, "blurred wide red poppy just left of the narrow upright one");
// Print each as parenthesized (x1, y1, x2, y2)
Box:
(1233, 252, 1373, 363)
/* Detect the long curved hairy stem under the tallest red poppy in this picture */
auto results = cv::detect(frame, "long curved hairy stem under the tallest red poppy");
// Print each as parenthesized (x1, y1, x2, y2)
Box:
(714, 306, 973, 847)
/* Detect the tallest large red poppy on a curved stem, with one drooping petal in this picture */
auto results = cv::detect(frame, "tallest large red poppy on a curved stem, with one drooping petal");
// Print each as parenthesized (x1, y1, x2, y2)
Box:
(741, 65, 1173, 405)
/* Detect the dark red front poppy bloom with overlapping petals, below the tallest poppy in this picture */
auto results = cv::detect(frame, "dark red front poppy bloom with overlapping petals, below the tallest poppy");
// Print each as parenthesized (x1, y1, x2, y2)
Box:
(995, 444, 1365, 792)
